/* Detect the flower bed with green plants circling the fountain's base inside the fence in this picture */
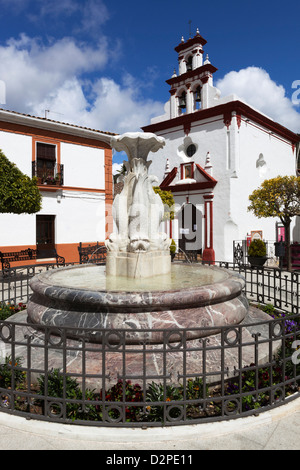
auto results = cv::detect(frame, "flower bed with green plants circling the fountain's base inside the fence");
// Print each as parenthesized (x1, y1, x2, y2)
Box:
(0, 306, 300, 424)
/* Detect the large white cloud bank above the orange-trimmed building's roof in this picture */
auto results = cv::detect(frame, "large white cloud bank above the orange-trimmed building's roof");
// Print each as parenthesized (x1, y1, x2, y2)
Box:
(0, 34, 163, 133)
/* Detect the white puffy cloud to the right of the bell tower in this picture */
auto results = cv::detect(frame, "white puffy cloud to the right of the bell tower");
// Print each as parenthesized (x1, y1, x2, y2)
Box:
(216, 67, 300, 132)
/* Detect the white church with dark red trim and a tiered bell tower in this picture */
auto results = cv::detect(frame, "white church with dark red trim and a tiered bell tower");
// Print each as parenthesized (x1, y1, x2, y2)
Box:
(142, 30, 300, 261)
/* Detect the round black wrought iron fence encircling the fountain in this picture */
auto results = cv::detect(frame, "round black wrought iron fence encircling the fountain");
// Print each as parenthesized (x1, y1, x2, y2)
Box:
(0, 263, 300, 427)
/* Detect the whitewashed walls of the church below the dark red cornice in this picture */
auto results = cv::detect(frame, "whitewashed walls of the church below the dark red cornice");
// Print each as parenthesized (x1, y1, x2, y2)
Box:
(149, 112, 300, 261)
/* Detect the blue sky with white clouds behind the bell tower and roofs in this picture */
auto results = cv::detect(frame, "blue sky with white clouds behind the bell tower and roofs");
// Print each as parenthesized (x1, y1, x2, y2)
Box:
(0, 0, 300, 168)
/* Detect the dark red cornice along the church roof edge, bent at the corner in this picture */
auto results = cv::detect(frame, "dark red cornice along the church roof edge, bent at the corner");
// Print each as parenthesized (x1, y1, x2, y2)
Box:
(142, 100, 300, 145)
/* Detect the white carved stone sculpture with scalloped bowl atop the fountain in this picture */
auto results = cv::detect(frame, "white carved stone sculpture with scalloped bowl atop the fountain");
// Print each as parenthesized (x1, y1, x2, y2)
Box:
(106, 133, 171, 278)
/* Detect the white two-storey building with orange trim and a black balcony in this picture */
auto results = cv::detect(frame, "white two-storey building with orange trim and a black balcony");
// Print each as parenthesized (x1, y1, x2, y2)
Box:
(0, 109, 114, 266)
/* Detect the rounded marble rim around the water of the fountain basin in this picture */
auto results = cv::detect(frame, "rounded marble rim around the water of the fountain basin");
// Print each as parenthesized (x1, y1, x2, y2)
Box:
(30, 264, 245, 310)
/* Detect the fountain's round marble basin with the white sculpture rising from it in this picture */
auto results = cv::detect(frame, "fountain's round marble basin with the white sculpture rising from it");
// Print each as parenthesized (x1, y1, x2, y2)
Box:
(27, 133, 248, 344)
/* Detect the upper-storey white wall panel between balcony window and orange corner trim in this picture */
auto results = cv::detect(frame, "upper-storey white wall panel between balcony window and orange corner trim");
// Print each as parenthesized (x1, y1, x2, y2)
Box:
(61, 143, 105, 189)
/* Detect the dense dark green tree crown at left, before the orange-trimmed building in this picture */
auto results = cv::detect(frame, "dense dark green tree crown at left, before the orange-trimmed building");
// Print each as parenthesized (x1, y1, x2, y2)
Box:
(0, 150, 42, 214)
